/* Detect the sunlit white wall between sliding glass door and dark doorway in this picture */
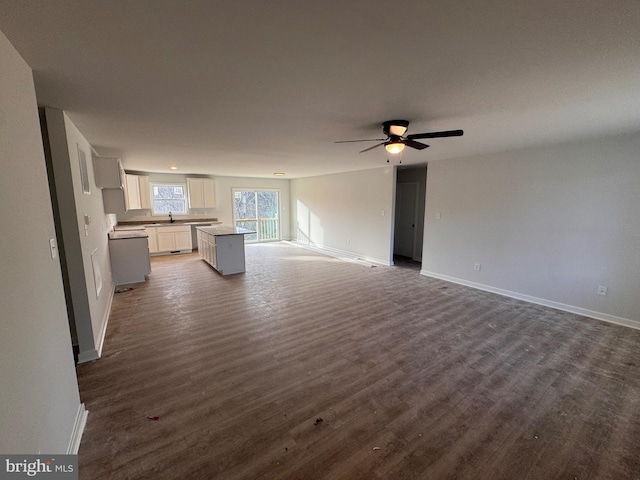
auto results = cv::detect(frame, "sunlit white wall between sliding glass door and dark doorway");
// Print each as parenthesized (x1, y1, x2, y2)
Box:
(291, 167, 395, 265)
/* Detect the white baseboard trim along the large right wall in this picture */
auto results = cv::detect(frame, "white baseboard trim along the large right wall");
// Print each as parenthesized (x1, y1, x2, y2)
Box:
(420, 270, 640, 330)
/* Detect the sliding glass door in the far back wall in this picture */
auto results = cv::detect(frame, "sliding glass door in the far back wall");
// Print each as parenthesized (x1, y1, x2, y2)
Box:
(233, 188, 280, 242)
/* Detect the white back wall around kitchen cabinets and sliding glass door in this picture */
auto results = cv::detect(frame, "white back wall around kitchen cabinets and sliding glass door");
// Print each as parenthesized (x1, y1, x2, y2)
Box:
(118, 171, 291, 240)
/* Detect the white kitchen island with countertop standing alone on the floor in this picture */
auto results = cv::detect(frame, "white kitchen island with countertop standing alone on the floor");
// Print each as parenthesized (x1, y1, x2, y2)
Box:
(196, 225, 256, 275)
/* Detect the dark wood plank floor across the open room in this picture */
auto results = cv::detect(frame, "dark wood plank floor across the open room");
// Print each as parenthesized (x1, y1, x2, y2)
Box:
(78, 243, 640, 480)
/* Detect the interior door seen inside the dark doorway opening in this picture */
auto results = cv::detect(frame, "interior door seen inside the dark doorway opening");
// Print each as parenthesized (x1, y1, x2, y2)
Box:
(393, 182, 418, 258)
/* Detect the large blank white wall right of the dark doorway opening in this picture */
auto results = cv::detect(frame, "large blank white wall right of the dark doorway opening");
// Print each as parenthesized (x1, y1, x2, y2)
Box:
(422, 134, 640, 327)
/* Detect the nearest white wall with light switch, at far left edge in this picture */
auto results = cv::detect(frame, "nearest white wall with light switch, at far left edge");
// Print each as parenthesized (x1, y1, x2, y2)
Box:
(0, 29, 83, 454)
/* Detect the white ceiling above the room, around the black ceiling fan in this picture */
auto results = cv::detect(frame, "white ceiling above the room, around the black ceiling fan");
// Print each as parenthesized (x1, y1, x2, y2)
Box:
(0, 0, 640, 178)
